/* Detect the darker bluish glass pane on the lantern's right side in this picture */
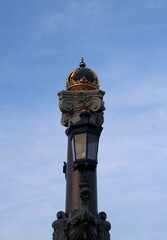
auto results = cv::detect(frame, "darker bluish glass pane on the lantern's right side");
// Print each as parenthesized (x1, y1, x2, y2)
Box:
(88, 134, 98, 160)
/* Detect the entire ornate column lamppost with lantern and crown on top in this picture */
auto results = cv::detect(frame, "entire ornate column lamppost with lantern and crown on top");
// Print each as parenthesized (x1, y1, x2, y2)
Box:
(52, 58, 111, 240)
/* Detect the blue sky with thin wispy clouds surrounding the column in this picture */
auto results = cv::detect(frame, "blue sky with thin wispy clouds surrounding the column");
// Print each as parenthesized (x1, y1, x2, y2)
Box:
(0, 0, 167, 240)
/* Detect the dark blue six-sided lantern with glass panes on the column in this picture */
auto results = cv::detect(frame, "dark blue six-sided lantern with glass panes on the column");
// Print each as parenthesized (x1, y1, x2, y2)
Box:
(67, 111, 103, 171)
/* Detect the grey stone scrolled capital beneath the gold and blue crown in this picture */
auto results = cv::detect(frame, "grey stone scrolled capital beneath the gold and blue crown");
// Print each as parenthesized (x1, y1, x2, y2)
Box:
(58, 90, 105, 127)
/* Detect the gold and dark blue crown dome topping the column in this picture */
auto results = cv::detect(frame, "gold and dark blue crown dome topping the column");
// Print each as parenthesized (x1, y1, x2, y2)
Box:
(66, 58, 99, 91)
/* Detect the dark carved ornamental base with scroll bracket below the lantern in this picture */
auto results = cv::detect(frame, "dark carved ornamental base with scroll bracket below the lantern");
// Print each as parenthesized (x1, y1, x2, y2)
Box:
(52, 182, 111, 240)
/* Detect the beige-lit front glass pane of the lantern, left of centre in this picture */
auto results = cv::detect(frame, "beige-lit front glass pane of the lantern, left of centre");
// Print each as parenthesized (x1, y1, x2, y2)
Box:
(74, 133, 86, 160)
